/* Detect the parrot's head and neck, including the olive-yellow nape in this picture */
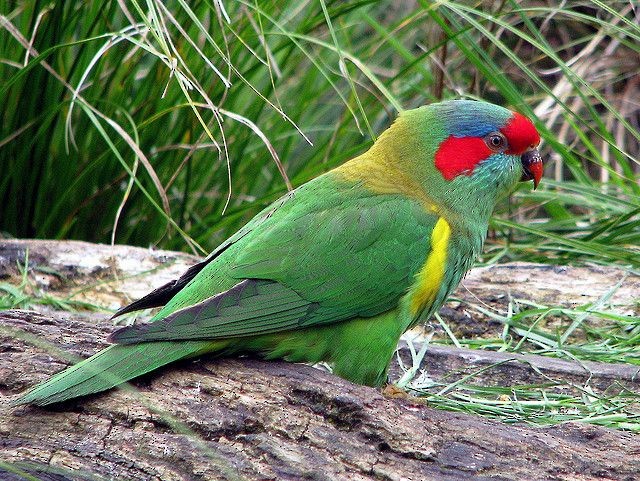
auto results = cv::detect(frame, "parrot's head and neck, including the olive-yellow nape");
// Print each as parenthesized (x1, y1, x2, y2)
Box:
(352, 100, 543, 220)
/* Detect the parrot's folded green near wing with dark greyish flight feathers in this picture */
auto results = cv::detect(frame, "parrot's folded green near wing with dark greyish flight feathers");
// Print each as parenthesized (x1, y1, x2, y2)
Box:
(111, 176, 437, 344)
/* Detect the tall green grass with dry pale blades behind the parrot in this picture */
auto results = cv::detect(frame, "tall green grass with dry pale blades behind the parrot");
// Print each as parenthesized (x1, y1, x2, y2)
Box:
(0, 0, 640, 428)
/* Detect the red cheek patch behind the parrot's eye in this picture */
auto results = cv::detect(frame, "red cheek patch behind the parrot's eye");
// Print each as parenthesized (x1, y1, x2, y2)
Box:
(434, 135, 492, 180)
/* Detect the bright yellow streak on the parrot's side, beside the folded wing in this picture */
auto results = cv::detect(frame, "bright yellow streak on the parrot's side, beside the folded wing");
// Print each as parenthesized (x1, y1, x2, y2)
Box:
(411, 217, 451, 315)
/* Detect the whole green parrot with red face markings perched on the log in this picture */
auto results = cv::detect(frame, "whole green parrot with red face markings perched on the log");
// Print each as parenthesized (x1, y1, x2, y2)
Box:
(16, 100, 543, 405)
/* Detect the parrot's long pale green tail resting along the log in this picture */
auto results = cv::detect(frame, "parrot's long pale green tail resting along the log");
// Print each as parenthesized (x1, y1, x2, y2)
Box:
(14, 341, 215, 406)
